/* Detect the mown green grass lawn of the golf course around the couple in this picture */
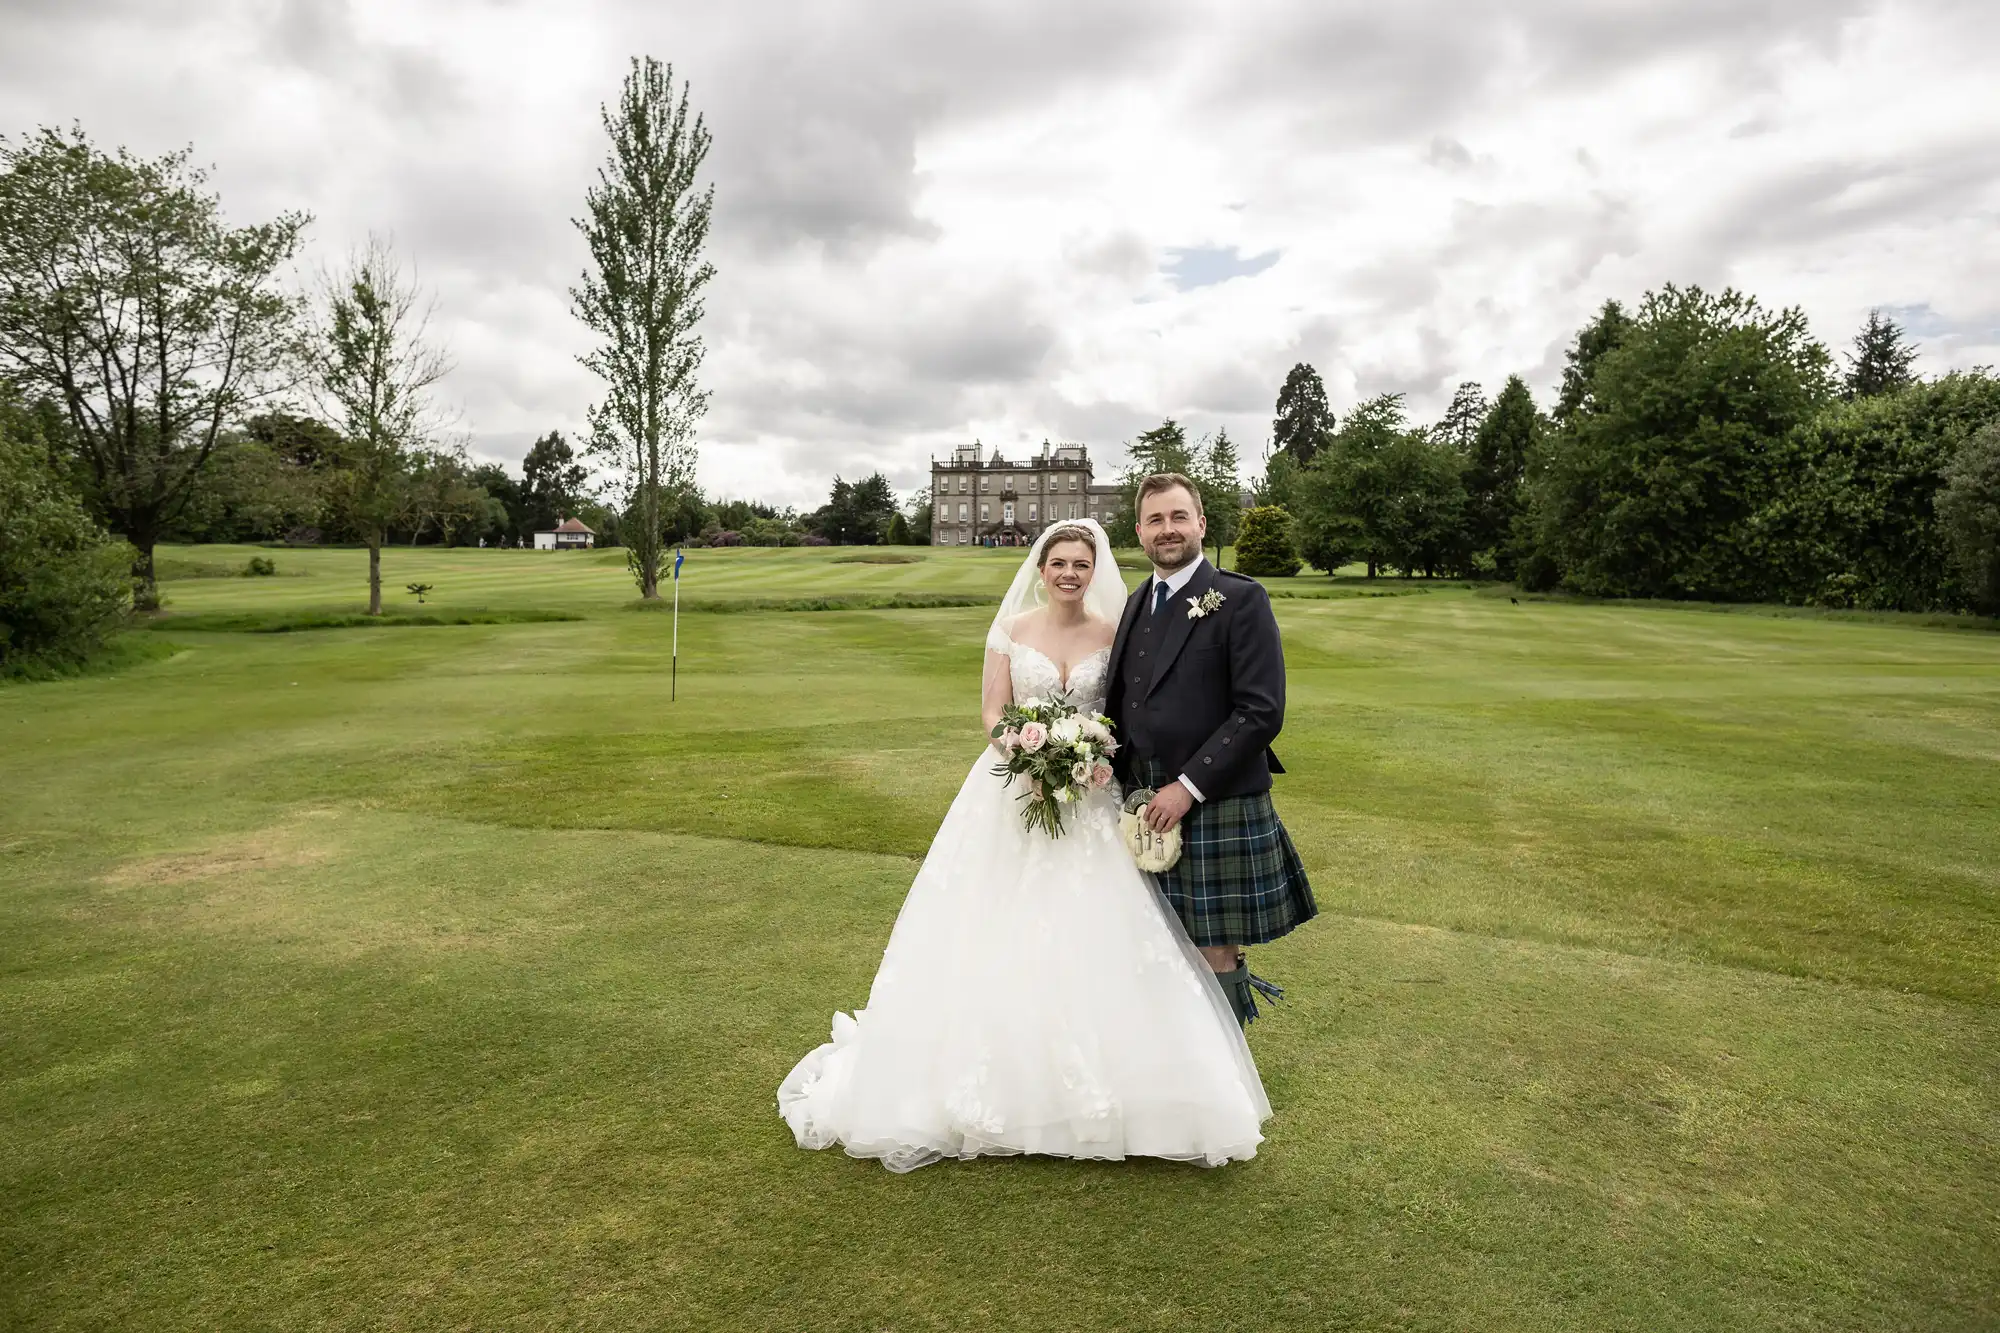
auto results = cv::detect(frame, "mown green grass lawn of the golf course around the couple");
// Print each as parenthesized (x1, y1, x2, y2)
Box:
(0, 548, 2000, 1331)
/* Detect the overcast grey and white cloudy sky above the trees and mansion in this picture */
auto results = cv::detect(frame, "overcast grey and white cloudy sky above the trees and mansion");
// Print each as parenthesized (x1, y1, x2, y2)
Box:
(0, 0, 2000, 504)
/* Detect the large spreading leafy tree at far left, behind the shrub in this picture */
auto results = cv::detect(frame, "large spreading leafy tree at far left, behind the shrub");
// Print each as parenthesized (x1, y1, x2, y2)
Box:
(0, 128, 308, 606)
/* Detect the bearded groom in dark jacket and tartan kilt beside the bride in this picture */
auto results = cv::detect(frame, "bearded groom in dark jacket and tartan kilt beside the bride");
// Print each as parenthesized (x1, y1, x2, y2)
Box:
(1106, 472, 1318, 1023)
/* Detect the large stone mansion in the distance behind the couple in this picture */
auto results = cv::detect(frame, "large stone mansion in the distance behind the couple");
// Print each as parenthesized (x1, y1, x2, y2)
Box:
(930, 440, 1120, 546)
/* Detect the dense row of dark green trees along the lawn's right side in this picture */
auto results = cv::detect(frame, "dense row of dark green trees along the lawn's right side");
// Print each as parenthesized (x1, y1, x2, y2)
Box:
(1238, 286, 2000, 612)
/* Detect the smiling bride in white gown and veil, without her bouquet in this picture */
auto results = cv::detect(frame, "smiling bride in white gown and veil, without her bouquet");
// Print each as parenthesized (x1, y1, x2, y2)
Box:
(778, 520, 1270, 1171)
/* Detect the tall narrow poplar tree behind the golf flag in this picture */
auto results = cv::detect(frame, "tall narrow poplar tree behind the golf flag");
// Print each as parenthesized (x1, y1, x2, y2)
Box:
(570, 56, 716, 600)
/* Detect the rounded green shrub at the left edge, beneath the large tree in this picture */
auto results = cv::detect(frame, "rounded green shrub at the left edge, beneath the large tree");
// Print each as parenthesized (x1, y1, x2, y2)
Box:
(0, 420, 134, 675)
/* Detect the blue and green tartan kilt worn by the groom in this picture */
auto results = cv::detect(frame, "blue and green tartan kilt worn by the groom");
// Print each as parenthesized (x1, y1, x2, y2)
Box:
(1132, 757, 1320, 947)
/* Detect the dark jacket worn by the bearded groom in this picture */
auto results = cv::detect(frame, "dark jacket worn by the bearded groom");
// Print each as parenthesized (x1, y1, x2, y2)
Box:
(1104, 560, 1284, 801)
